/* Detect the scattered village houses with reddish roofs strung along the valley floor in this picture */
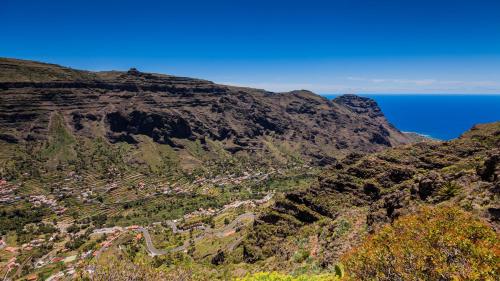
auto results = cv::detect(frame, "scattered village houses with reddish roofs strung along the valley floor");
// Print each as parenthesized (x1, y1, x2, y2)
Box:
(0, 164, 282, 280)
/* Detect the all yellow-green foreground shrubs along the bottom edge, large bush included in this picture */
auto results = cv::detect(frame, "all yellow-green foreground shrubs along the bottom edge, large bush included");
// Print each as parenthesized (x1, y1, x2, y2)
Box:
(76, 205, 500, 281)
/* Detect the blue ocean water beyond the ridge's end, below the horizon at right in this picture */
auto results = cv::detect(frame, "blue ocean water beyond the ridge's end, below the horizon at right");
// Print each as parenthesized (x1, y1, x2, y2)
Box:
(325, 94, 500, 140)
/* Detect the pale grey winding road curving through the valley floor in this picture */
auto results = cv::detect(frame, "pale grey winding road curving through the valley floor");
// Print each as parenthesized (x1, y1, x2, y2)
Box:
(138, 213, 255, 257)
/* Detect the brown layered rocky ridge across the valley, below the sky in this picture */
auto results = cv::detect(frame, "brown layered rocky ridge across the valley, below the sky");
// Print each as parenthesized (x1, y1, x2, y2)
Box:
(0, 59, 411, 165)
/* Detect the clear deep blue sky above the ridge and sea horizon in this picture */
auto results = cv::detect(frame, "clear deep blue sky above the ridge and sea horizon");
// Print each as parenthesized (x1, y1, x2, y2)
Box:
(0, 0, 500, 93)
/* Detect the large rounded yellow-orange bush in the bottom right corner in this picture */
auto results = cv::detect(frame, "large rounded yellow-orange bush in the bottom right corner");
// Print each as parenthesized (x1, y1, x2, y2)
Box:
(344, 207, 500, 280)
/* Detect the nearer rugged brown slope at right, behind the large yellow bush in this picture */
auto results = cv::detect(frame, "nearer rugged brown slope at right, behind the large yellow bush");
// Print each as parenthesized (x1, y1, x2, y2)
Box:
(243, 123, 500, 267)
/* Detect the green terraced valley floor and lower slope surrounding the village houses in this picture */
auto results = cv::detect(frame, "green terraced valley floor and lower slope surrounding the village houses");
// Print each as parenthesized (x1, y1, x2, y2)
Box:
(0, 113, 318, 280)
